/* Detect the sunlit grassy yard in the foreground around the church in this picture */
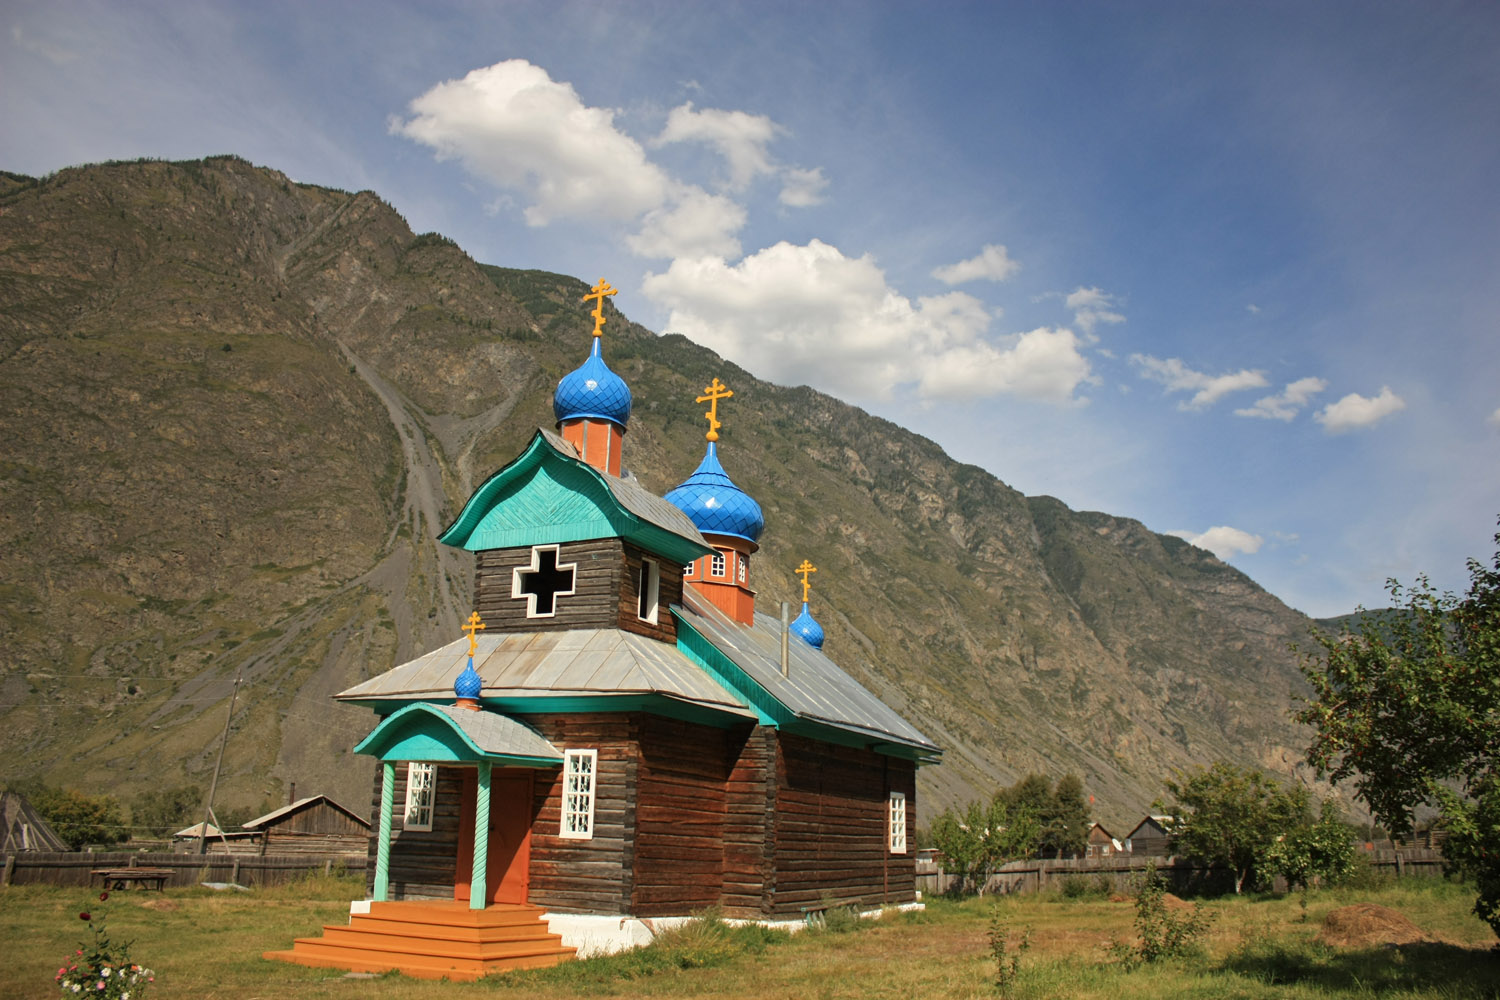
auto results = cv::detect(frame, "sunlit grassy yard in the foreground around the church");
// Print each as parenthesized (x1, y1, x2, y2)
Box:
(0, 879, 1500, 1000)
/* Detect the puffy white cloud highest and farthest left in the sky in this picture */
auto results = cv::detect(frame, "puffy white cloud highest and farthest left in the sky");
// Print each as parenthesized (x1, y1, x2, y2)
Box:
(390, 58, 671, 226)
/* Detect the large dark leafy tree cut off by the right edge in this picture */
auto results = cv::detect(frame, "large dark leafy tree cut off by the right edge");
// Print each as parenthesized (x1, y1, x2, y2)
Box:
(1296, 534, 1500, 934)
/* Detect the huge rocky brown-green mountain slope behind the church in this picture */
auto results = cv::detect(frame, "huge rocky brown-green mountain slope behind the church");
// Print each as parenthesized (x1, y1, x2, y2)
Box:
(0, 157, 1308, 823)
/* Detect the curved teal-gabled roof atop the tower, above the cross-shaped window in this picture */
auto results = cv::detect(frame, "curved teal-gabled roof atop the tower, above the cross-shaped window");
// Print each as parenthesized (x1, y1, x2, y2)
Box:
(438, 430, 713, 564)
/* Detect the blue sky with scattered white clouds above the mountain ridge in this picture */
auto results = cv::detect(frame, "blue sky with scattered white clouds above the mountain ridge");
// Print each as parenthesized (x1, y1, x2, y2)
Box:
(0, 0, 1500, 615)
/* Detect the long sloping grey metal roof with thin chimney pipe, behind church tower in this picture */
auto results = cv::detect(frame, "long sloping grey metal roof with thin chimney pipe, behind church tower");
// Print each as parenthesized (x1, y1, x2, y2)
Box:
(672, 586, 942, 753)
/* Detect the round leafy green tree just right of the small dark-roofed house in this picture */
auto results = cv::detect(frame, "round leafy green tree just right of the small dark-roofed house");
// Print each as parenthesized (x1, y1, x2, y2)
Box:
(1167, 762, 1310, 894)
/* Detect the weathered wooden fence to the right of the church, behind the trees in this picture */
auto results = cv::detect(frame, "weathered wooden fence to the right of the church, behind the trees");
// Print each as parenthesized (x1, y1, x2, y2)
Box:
(917, 847, 1443, 895)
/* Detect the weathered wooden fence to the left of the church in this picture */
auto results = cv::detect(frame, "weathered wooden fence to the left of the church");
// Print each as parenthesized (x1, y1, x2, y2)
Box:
(0, 850, 366, 886)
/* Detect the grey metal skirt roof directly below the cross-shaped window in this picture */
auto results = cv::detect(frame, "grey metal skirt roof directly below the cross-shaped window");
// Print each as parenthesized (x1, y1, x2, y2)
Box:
(343, 628, 755, 718)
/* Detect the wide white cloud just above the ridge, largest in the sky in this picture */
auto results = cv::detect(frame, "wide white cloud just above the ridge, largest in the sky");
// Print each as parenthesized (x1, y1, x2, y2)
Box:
(642, 240, 1089, 403)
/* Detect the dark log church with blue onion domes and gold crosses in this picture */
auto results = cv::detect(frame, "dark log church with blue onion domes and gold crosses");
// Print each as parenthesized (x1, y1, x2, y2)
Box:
(267, 282, 941, 978)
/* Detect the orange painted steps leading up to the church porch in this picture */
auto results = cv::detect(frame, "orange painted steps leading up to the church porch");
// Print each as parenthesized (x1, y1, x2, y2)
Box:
(264, 901, 575, 981)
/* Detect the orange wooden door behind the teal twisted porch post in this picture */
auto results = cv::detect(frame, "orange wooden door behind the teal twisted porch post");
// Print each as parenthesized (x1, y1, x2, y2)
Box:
(453, 769, 531, 903)
